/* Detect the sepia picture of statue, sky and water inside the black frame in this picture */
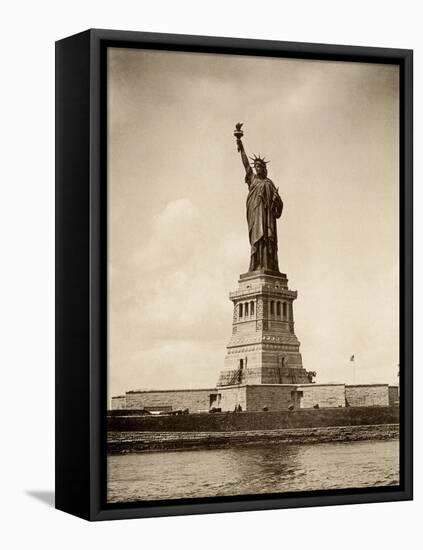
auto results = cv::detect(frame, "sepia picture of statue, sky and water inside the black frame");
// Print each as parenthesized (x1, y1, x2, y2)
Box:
(106, 47, 401, 504)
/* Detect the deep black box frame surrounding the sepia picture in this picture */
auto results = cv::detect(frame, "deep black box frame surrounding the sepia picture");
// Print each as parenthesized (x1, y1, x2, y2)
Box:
(55, 29, 413, 520)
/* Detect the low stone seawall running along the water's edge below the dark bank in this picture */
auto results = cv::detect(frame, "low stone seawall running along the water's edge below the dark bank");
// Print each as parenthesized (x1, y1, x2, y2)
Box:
(107, 423, 399, 455)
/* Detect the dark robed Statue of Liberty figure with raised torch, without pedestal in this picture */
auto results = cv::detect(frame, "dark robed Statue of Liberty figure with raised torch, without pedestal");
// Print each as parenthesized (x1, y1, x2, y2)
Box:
(234, 123, 283, 273)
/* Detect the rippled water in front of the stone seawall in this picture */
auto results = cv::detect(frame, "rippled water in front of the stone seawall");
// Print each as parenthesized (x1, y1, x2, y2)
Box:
(108, 440, 399, 502)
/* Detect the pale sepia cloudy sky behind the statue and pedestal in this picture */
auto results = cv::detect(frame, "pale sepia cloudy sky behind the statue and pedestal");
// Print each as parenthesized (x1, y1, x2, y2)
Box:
(108, 48, 399, 402)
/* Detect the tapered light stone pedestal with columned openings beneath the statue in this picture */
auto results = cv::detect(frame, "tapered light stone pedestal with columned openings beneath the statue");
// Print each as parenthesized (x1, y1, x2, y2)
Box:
(217, 269, 309, 386)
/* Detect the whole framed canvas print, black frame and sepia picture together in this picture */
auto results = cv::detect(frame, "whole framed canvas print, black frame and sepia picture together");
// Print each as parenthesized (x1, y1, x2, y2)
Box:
(56, 30, 412, 520)
